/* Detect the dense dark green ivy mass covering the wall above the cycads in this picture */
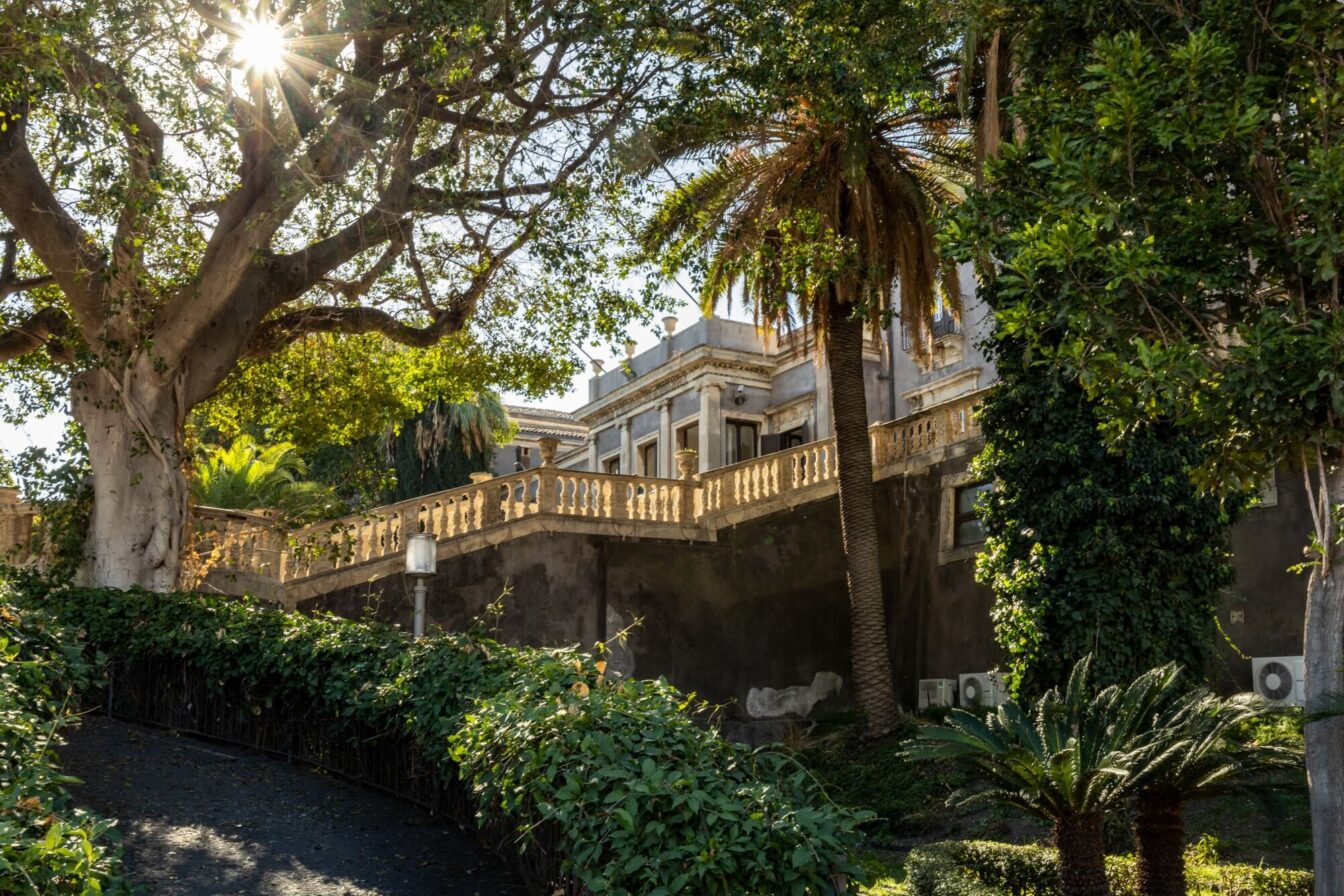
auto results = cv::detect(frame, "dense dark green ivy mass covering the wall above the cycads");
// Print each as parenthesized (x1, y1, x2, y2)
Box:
(974, 341, 1242, 696)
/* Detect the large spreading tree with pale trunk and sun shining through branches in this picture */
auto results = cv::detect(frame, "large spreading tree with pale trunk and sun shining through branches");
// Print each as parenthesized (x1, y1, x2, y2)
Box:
(0, 0, 681, 590)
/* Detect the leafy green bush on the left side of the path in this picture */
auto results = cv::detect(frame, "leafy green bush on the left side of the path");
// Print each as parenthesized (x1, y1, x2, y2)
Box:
(0, 584, 129, 896)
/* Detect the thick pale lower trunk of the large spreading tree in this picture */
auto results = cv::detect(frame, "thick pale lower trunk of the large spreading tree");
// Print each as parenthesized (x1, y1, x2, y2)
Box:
(71, 369, 187, 591)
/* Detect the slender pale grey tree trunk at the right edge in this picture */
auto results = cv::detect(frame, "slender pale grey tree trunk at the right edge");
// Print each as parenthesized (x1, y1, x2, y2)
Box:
(1302, 459, 1344, 895)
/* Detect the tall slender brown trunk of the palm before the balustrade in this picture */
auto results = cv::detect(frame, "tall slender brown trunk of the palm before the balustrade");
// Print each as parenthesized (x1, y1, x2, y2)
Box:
(827, 295, 900, 733)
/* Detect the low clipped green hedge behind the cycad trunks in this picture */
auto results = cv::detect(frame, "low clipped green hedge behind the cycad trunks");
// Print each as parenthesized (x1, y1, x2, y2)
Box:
(906, 841, 1312, 896)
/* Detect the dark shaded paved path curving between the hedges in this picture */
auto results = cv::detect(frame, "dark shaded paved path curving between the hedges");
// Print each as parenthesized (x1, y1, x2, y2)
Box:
(60, 716, 524, 896)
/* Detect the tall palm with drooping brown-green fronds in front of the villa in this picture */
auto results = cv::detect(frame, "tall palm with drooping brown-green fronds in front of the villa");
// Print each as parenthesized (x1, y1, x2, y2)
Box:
(640, 102, 970, 731)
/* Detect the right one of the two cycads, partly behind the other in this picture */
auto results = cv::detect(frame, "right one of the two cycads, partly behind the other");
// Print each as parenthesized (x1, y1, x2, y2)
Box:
(1134, 685, 1302, 896)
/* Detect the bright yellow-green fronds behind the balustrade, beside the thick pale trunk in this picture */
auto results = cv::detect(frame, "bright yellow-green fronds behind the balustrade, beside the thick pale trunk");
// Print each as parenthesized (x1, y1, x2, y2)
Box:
(191, 435, 341, 520)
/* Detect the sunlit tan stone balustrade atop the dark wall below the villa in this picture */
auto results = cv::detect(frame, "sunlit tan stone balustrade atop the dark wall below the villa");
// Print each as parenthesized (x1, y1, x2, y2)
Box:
(0, 390, 984, 603)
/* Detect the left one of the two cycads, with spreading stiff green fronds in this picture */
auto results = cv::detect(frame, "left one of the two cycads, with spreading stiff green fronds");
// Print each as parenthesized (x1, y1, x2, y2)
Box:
(906, 658, 1177, 896)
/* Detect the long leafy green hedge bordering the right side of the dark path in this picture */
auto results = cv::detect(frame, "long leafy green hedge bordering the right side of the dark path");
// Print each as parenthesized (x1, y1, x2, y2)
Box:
(36, 590, 866, 896)
